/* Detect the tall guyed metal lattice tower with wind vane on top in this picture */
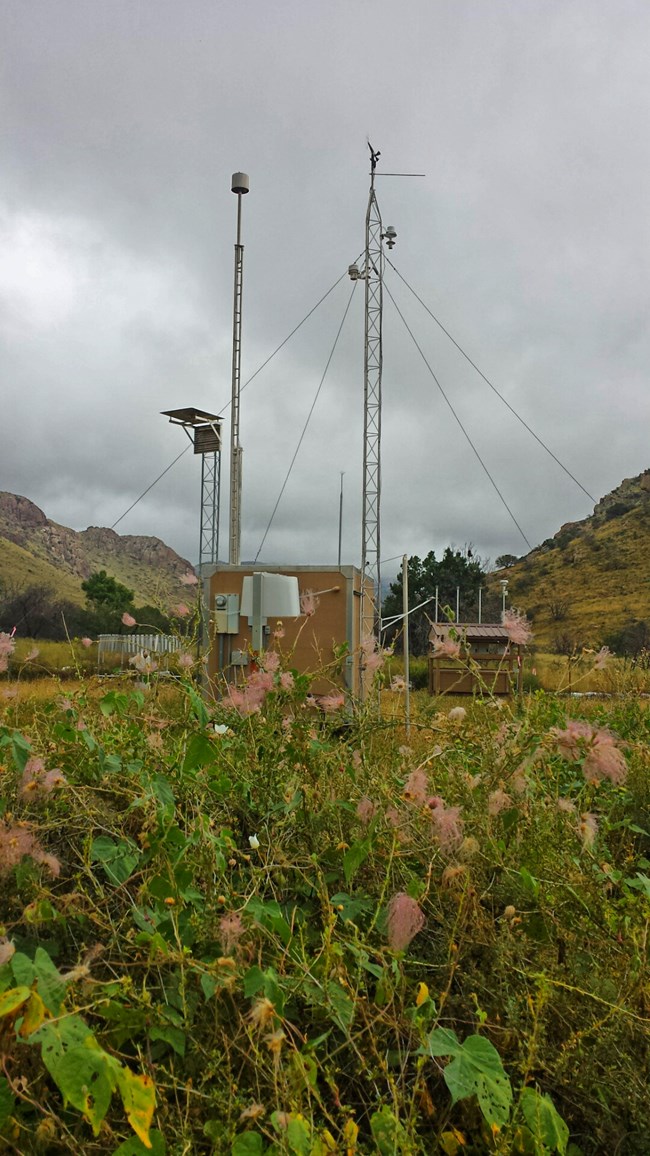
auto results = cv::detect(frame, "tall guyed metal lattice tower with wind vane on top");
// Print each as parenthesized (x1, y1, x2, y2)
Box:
(361, 148, 384, 638)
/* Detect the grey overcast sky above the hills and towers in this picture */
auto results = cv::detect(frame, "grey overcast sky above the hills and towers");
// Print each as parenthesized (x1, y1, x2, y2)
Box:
(0, 0, 650, 577)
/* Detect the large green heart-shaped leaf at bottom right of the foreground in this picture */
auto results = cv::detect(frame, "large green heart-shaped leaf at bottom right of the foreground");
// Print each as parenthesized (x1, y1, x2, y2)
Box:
(428, 1028, 512, 1127)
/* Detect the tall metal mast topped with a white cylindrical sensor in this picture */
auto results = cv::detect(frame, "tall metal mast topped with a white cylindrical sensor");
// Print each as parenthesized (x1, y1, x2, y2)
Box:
(228, 172, 249, 566)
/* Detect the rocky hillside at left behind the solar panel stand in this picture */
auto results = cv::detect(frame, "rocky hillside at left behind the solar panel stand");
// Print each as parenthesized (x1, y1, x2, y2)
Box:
(0, 491, 192, 607)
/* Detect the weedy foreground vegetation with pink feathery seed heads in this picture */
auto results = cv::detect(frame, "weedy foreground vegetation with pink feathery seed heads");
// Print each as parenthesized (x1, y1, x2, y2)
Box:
(0, 628, 650, 1156)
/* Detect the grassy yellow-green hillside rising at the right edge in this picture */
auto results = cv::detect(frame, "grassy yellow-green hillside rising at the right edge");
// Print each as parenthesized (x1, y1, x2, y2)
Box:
(494, 469, 650, 650)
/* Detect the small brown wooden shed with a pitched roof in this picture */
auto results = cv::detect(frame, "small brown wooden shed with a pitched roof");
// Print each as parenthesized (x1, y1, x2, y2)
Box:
(429, 622, 520, 695)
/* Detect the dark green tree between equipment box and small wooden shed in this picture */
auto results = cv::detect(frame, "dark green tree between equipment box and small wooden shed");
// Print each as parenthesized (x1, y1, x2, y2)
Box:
(382, 546, 486, 654)
